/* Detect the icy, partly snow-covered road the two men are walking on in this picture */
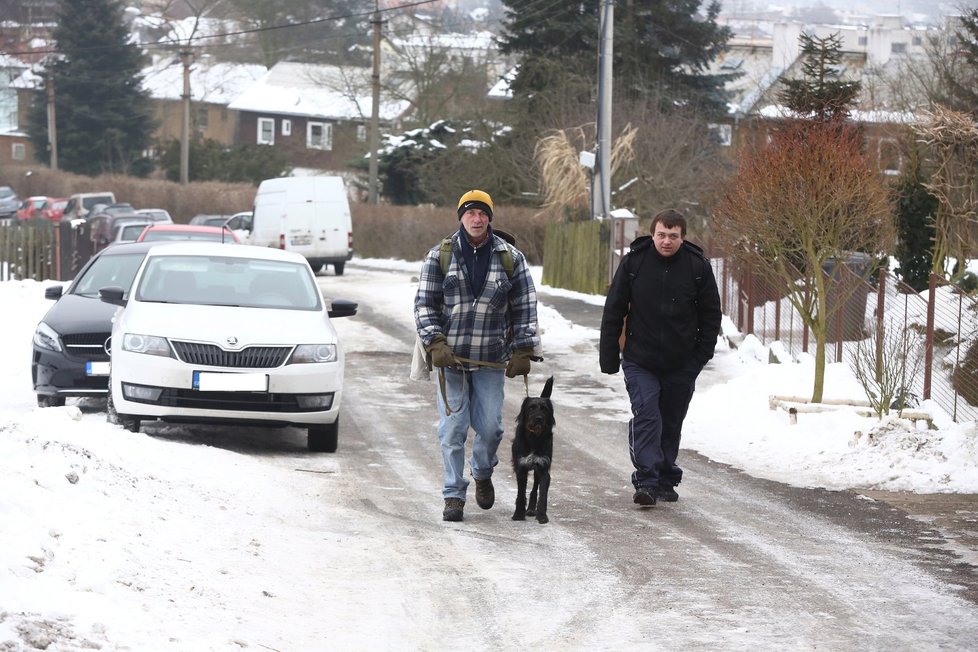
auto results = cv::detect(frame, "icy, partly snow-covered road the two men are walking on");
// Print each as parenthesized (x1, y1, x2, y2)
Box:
(308, 262, 978, 650)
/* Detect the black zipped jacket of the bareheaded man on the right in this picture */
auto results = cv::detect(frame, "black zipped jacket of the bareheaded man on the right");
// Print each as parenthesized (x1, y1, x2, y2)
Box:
(600, 236, 721, 374)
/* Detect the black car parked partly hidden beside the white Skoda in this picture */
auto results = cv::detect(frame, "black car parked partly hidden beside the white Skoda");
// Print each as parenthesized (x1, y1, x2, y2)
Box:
(31, 242, 158, 407)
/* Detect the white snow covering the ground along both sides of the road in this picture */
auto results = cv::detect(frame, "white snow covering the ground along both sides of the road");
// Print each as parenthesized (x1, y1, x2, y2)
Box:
(0, 261, 978, 651)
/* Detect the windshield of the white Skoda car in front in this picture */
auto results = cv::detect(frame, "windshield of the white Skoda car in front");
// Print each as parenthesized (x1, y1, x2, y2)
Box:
(136, 255, 322, 310)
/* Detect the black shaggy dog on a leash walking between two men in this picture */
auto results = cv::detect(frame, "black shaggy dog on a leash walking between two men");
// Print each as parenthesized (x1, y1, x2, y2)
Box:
(513, 376, 556, 523)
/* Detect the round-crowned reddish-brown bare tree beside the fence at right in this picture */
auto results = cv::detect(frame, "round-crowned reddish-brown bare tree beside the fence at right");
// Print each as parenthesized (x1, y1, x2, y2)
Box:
(714, 122, 895, 402)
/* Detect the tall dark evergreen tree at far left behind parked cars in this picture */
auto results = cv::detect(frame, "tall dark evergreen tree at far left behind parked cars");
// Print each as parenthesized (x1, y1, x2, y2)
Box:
(29, 0, 155, 176)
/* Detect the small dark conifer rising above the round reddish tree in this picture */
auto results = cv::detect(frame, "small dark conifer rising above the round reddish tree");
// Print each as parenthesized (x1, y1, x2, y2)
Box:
(779, 34, 860, 122)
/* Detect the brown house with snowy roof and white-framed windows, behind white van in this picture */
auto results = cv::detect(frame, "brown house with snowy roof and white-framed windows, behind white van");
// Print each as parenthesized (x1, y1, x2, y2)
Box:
(228, 61, 411, 170)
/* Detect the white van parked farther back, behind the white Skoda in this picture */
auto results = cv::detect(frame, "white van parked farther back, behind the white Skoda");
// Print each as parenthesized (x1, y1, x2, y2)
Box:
(227, 177, 353, 276)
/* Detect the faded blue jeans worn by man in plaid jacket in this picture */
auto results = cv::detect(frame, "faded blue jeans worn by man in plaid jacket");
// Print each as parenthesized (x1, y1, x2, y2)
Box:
(435, 367, 506, 500)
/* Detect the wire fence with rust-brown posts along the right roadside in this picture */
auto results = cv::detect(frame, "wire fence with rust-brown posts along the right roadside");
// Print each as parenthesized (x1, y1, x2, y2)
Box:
(712, 258, 978, 422)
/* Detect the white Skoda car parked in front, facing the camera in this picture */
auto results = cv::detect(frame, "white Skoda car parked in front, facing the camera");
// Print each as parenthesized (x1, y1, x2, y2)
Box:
(99, 242, 357, 452)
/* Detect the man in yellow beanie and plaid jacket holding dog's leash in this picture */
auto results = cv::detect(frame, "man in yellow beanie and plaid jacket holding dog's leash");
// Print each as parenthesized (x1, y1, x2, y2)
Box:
(414, 190, 540, 521)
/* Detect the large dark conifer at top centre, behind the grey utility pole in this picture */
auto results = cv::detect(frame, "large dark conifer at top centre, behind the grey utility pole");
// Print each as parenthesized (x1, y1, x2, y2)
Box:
(501, 0, 731, 114)
